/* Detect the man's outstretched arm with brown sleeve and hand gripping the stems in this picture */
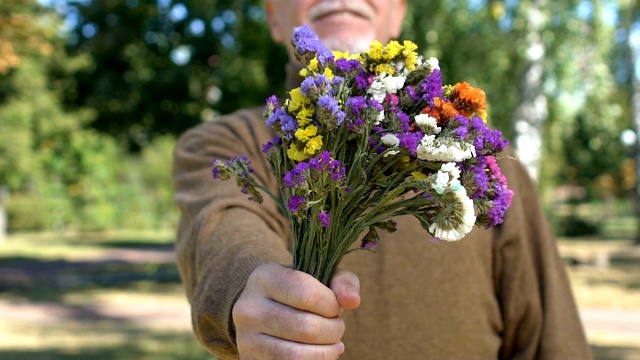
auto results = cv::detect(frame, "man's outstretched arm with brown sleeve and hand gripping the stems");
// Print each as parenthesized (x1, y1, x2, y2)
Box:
(174, 112, 360, 359)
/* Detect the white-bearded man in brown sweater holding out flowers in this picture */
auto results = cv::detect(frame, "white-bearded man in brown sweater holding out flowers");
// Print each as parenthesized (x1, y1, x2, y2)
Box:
(174, 0, 590, 359)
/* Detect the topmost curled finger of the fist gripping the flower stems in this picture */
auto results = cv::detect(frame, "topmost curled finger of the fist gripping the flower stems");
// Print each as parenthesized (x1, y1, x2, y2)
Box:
(258, 265, 340, 318)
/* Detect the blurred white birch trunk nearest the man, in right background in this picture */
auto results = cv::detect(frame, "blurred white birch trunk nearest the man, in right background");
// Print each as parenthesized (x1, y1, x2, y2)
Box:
(514, 0, 548, 181)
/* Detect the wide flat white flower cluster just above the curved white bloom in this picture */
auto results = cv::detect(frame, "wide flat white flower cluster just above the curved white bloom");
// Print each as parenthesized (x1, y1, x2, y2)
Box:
(416, 135, 476, 162)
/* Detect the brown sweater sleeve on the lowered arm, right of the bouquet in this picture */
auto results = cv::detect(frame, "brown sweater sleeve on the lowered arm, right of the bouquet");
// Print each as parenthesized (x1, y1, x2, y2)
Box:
(494, 148, 591, 359)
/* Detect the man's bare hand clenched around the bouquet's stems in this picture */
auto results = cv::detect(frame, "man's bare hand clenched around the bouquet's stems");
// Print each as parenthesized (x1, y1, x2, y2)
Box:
(233, 264, 360, 359)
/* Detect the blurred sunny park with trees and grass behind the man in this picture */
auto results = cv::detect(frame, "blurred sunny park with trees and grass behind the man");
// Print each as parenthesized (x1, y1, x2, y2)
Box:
(0, 0, 640, 360)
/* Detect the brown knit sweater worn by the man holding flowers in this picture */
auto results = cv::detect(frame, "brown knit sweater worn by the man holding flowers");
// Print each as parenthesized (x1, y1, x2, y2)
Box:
(174, 69, 591, 360)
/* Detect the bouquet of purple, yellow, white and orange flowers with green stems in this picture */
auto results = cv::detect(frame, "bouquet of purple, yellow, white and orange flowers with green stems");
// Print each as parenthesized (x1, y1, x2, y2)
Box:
(213, 25, 513, 284)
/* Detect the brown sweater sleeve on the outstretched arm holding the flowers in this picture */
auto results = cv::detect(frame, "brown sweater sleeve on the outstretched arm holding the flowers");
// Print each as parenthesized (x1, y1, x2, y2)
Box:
(173, 110, 291, 359)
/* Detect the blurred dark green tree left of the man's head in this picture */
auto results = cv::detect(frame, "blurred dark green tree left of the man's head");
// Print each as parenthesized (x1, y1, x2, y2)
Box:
(67, 0, 285, 150)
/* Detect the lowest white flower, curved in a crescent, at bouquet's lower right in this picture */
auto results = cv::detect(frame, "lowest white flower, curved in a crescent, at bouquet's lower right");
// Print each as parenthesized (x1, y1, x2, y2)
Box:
(429, 188, 476, 241)
